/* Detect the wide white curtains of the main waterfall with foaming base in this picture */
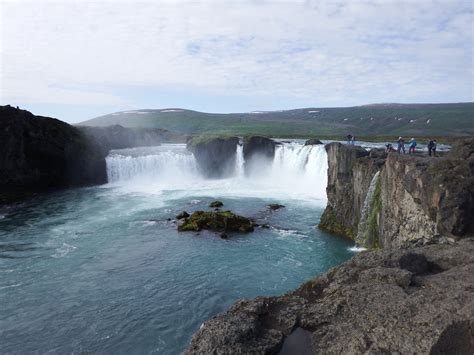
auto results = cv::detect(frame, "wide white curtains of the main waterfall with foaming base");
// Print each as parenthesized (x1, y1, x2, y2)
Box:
(106, 143, 327, 204)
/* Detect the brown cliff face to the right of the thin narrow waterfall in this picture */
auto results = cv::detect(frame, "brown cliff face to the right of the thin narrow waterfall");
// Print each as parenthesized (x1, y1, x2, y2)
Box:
(379, 155, 474, 247)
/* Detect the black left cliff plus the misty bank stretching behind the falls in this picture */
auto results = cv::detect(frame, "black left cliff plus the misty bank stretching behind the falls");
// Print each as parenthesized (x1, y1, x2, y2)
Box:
(0, 106, 184, 204)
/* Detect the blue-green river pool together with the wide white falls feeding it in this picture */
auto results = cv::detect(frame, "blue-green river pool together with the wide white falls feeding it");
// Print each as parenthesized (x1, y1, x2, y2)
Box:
(0, 142, 353, 354)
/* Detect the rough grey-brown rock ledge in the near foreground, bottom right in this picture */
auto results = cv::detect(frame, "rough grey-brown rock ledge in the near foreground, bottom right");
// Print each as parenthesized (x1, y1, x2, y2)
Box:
(185, 239, 474, 354)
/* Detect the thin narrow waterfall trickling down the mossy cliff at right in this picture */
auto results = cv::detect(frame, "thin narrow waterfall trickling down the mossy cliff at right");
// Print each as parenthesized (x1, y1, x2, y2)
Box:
(355, 171, 380, 248)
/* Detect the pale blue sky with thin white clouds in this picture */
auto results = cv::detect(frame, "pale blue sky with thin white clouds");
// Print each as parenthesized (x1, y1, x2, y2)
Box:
(0, 0, 474, 123)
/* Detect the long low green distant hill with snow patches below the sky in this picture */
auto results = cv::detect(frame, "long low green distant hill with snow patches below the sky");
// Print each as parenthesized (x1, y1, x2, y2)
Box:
(80, 102, 474, 137)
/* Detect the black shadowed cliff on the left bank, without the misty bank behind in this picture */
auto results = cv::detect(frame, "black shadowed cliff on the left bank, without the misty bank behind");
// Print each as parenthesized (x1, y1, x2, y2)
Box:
(0, 106, 107, 189)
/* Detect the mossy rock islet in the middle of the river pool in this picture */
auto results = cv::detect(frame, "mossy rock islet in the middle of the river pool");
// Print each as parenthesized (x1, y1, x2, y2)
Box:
(178, 211, 254, 233)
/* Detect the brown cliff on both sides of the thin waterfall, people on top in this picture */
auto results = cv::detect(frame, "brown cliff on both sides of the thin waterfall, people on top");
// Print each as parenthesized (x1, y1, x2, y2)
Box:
(320, 140, 474, 247)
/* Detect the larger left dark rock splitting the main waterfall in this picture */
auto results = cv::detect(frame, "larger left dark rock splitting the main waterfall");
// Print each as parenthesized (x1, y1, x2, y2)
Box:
(187, 137, 239, 178)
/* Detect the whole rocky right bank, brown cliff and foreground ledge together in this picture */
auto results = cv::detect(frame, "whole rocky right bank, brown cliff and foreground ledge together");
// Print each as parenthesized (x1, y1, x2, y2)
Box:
(185, 139, 474, 355)
